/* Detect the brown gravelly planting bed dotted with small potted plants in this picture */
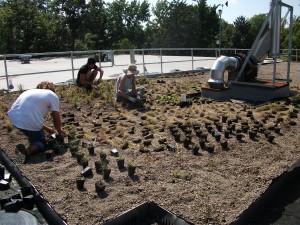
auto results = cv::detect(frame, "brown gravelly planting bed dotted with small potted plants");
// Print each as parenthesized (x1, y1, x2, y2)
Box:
(0, 62, 300, 225)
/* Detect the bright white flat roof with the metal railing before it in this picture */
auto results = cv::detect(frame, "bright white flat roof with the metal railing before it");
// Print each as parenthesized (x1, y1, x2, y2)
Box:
(0, 48, 300, 90)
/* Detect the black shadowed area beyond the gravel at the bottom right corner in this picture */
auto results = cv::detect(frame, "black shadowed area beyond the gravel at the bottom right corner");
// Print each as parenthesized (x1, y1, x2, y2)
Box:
(231, 160, 300, 225)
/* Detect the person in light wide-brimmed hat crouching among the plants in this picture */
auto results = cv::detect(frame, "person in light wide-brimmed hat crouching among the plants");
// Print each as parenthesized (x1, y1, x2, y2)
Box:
(116, 64, 140, 103)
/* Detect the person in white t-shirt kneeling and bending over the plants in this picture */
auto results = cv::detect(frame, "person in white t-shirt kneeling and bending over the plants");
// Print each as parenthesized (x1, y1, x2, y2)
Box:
(8, 81, 65, 160)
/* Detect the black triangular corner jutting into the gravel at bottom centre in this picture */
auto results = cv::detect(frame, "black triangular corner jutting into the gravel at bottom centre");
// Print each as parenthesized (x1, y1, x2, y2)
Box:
(101, 201, 193, 225)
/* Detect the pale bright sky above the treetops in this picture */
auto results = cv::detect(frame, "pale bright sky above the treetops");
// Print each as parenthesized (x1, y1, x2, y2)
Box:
(106, 0, 300, 24)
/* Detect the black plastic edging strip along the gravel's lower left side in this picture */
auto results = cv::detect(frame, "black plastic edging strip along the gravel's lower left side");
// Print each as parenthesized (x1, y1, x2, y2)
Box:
(0, 148, 67, 225)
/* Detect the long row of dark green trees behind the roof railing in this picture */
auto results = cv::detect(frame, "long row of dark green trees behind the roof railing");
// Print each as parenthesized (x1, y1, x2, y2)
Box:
(0, 0, 300, 54)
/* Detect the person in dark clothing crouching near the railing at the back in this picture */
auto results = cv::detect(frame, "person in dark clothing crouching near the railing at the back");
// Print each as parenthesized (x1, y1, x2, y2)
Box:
(76, 58, 104, 89)
